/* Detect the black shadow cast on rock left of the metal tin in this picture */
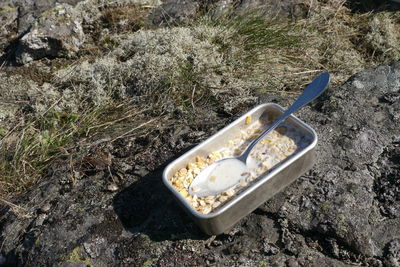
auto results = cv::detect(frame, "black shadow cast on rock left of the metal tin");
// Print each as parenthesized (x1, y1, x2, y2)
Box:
(113, 158, 208, 241)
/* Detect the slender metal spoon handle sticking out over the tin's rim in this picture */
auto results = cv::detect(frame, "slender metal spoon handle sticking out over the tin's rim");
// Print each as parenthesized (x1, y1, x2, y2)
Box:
(238, 72, 330, 163)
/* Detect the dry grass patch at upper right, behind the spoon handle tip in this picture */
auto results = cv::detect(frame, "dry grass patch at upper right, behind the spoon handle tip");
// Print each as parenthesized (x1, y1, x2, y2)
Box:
(203, 0, 400, 92)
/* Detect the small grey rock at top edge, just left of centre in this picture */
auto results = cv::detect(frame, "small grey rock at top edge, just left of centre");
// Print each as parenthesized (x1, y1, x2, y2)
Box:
(148, 0, 199, 26)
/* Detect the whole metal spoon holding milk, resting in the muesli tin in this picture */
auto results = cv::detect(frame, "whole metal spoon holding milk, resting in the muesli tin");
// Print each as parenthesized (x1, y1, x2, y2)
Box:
(189, 72, 330, 197)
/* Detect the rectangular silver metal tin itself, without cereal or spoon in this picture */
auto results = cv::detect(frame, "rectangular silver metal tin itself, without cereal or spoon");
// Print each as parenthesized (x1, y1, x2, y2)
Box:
(163, 103, 317, 235)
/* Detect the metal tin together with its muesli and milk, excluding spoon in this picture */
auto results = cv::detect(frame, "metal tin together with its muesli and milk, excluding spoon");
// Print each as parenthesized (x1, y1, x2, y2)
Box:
(162, 103, 318, 235)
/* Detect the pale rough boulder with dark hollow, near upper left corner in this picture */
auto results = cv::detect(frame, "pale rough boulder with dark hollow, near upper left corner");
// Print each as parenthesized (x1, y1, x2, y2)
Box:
(16, 4, 84, 64)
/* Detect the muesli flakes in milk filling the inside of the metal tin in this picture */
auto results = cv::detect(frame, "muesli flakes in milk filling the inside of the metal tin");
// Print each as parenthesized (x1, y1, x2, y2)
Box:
(168, 114, 313, 214)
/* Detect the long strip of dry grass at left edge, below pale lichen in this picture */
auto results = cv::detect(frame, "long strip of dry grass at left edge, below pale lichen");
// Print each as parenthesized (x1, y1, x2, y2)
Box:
(0, 102, 154, 199)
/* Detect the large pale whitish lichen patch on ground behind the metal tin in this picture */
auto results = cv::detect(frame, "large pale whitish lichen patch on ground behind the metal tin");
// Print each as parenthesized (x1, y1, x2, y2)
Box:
(57, 25, 254, 111)
